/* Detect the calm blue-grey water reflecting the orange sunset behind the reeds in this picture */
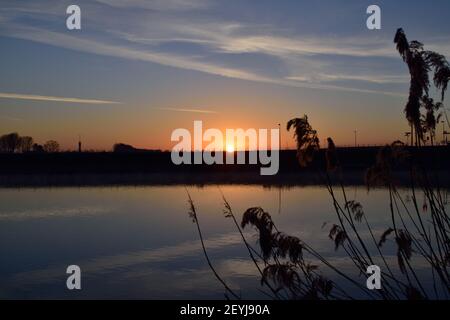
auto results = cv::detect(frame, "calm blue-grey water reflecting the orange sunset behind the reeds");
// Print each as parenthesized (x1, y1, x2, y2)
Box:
(0, 185, 446, 299)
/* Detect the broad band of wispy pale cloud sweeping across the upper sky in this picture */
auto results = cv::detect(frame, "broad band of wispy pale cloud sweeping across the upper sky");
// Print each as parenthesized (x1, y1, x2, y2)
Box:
(0, 0, 450, 95)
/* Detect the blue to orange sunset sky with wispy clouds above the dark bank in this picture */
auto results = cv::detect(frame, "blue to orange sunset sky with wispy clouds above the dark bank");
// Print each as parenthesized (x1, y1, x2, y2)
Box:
(0, 0, 450, 150)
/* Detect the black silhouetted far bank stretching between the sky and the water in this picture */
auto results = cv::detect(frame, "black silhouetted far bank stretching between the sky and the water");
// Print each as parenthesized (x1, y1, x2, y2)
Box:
(0, 146, 450, 187)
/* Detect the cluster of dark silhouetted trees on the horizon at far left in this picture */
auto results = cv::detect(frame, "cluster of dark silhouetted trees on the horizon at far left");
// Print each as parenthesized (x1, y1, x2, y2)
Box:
(0, 132, 60, 153)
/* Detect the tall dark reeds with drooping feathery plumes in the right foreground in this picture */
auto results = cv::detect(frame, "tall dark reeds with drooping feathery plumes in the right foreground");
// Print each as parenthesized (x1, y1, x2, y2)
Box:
(188, 29, 450, 300)
